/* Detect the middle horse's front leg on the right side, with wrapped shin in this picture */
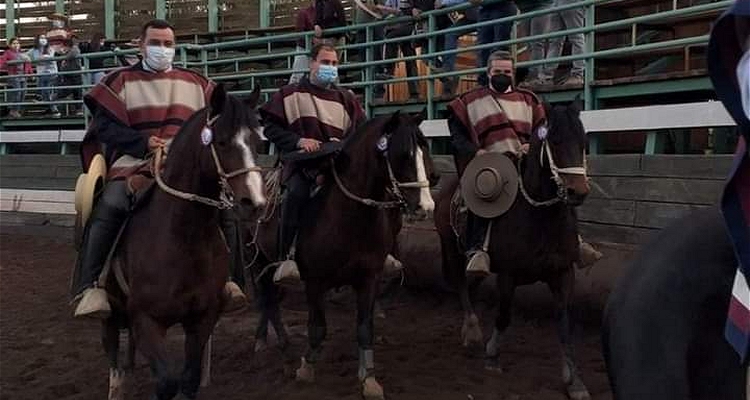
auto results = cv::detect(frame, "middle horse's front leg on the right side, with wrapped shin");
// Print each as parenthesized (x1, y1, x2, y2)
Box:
(355, 275, 385, 400)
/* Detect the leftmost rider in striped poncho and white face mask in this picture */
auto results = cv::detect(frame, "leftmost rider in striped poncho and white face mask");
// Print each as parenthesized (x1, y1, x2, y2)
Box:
(72, 20, 245, 318)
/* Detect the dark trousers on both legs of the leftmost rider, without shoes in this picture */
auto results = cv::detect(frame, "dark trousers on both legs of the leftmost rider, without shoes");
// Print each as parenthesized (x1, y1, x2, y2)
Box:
(72, 180, 244, 296)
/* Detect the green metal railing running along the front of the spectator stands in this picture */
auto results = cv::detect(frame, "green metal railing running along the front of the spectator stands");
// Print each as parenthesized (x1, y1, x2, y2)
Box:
(0, 0, 733, 126)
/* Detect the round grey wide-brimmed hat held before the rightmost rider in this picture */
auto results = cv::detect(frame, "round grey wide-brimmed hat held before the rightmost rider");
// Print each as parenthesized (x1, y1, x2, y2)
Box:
(461, 152, 518, 218)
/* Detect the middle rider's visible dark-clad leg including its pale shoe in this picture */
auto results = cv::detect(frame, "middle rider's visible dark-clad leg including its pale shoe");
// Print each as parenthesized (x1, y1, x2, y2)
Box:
(274, 170, 312, 282)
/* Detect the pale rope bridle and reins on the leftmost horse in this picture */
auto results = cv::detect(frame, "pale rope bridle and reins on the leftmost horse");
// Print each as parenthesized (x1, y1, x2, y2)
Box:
(152, 111, 262, 210)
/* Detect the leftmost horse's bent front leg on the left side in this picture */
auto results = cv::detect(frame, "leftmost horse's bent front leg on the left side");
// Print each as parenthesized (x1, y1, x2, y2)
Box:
(133, 315, 180, 400)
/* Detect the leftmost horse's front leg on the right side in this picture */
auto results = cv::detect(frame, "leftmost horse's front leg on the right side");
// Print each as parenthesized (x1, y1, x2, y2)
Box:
(180, 309, 219, 399)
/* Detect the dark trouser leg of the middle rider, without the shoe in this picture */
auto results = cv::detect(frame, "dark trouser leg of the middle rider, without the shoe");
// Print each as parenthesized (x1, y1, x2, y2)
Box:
(279, 169, 313, 261)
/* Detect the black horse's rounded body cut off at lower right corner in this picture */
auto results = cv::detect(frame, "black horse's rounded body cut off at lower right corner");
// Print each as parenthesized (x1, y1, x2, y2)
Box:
(602, 208, 750, 400)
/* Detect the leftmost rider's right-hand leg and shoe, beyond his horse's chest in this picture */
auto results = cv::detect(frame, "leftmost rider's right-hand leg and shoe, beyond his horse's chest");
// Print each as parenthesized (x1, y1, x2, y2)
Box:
(221, 209, 247, 312)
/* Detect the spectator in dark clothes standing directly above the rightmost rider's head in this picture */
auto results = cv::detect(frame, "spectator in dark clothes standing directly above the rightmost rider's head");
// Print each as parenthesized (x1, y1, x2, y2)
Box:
(476, 0, 518, 86)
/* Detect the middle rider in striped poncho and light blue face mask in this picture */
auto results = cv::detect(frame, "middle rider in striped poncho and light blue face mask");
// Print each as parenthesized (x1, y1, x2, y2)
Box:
(260, 44, 400, 283)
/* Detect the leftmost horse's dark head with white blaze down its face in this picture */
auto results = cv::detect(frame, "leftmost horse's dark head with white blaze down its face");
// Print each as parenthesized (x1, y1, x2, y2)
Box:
(208, 84, 266, 207)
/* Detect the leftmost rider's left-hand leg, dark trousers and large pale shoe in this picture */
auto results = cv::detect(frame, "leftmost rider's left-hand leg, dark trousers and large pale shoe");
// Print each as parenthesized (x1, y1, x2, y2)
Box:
(73, 180, 132, 318)
